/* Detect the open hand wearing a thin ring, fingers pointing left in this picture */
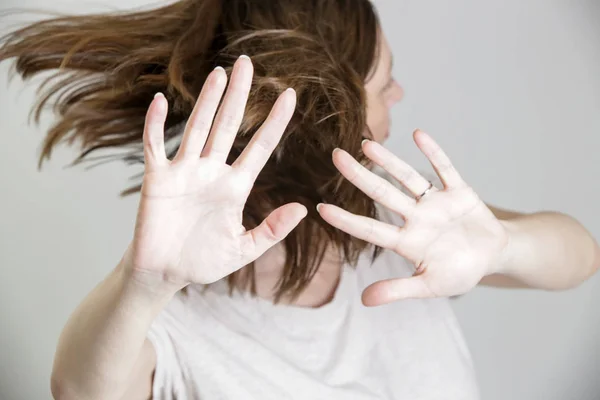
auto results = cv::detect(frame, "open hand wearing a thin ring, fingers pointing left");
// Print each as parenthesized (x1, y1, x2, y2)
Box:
(318, 130, 509, 305)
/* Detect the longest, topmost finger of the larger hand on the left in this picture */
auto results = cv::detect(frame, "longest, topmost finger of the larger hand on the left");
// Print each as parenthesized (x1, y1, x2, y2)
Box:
(202, 56, 253, 162)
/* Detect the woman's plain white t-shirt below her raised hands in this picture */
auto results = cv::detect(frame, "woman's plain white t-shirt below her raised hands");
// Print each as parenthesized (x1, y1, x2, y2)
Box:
(148, 200, 479, 400)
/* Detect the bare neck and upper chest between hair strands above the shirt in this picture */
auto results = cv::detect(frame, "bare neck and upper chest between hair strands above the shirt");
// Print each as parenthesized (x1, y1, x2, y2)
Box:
(255, 244, 343, 307)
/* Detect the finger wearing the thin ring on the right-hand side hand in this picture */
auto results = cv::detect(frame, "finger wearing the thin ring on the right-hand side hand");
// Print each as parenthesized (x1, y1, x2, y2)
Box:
(363, 140, 430, 196)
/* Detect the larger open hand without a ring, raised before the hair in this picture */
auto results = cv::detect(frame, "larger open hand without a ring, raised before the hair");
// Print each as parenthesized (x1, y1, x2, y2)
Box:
(123, 56, 307, 289)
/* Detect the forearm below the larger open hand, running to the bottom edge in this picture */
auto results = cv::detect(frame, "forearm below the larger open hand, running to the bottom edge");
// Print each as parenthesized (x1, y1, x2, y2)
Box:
(52, 255, 172, 399)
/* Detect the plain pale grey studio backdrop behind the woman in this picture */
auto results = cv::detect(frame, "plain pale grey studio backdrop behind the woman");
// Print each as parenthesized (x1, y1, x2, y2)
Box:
(0, 0, 600, 400)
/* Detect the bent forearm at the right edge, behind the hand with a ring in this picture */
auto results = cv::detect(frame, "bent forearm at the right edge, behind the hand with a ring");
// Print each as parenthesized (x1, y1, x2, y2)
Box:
(498, 212, 600, 290)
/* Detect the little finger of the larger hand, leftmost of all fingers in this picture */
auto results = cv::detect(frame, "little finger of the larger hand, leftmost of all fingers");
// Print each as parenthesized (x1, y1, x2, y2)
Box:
(142, 93, 169, 168)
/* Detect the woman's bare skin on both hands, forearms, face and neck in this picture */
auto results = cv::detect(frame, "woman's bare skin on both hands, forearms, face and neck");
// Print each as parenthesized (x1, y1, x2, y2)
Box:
(51, 35, 600, 399)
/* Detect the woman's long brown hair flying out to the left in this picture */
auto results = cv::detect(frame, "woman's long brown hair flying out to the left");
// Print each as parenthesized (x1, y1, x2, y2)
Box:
(0, 0, 380, 301)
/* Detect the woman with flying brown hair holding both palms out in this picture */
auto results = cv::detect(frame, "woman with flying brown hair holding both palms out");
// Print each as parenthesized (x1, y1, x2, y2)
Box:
(0, 0, 600, 399)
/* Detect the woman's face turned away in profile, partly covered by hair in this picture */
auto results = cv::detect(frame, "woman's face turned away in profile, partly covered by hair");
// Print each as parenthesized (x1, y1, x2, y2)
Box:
(365, 33, 404, 143)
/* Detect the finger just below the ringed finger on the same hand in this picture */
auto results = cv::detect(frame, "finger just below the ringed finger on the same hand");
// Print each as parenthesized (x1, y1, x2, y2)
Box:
(333, 149, 417, 218)
